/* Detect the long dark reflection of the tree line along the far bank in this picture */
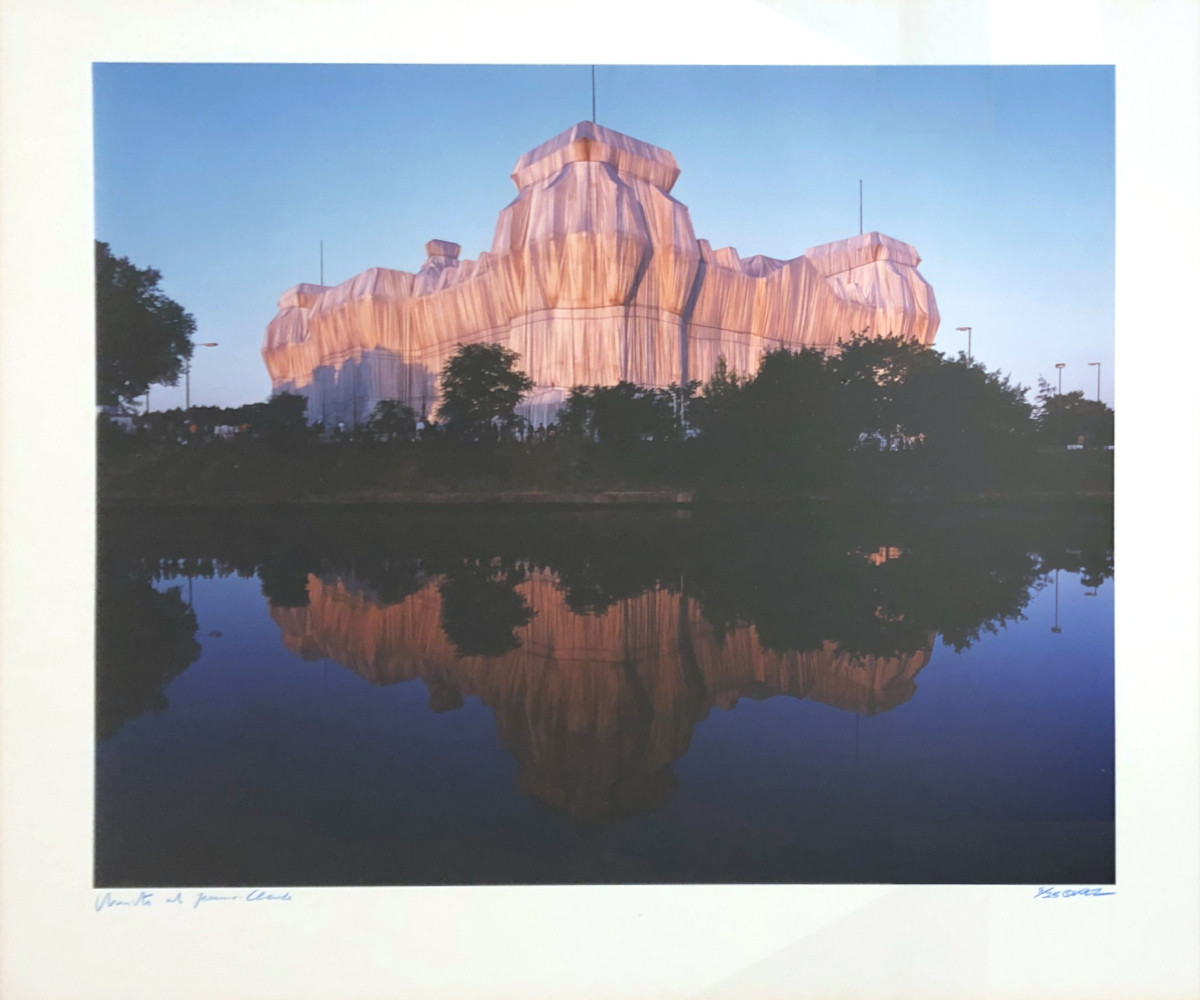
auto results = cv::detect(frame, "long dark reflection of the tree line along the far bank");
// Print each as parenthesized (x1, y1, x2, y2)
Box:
(103, 507, 1112, 655)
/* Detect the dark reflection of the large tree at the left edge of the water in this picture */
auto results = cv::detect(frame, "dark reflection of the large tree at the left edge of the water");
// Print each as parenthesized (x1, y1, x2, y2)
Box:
(96, 573, 200, 739)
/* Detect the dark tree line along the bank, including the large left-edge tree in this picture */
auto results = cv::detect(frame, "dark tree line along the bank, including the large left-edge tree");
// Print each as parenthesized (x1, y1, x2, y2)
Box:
(96, 242, 1114, 489)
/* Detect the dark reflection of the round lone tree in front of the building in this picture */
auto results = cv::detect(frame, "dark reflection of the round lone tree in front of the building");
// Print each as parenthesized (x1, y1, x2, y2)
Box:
(438, 562, 535, 657)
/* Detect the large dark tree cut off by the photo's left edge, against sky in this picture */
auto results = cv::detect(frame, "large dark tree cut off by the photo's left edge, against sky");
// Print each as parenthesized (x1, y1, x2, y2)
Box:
(96, 240, 196, 405)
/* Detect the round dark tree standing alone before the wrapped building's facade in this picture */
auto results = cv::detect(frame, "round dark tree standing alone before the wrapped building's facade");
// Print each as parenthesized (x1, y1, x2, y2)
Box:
(438, 343, 533, 441)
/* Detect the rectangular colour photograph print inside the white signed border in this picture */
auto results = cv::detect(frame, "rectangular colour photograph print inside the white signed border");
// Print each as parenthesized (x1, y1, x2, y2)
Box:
(92, 64, 1116, 891)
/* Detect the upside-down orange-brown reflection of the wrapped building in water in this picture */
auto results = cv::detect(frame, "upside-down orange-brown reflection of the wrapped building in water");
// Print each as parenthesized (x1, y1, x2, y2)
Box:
(271, 573, 934, 820)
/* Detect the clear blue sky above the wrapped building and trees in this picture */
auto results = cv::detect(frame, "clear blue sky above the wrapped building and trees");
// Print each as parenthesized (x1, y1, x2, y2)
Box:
(94, 64, 1115, 409)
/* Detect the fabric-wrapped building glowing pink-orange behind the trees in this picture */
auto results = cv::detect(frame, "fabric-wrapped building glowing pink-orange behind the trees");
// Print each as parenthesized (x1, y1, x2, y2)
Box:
(263, 121, 938, 426)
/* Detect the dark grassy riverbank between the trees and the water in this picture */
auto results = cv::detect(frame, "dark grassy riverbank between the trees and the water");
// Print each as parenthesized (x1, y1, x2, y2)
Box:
(97, 441, 1112, 508)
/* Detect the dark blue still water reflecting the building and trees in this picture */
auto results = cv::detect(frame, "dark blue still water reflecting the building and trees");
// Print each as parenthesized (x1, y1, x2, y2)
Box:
(96, 510, 1115, 887)
